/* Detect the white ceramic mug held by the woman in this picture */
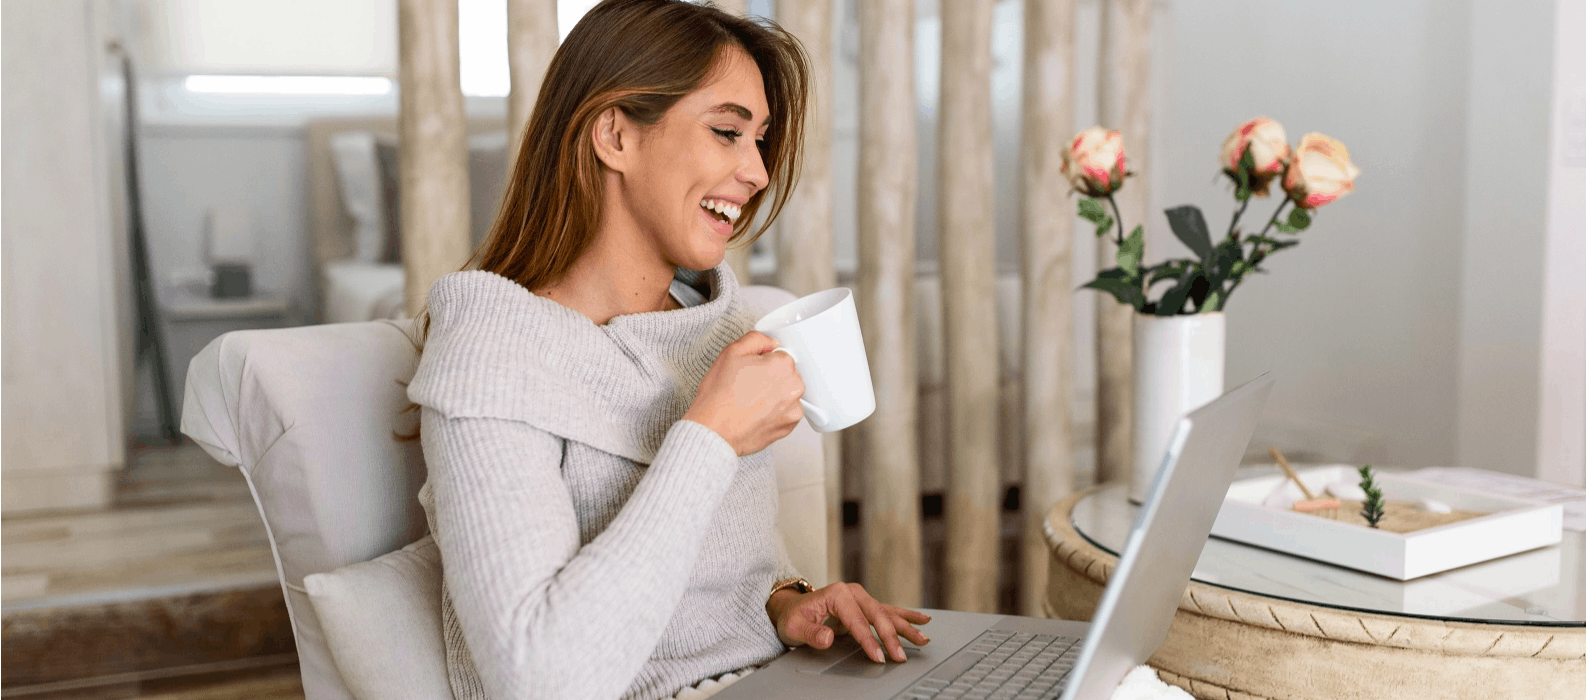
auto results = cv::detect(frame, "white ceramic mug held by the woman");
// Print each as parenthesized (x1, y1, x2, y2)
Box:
(755, 287, 875, 433)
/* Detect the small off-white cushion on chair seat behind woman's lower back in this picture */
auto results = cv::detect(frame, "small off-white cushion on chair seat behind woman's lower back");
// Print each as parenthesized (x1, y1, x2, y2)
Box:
(303, 535, 452, 700)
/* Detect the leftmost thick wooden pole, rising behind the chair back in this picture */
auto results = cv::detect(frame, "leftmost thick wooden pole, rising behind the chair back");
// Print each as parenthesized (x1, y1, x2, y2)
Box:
(397, 0, 473, 316)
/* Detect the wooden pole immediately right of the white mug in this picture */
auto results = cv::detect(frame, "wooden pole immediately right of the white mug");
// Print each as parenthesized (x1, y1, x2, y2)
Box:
(855, 0, 920, 606)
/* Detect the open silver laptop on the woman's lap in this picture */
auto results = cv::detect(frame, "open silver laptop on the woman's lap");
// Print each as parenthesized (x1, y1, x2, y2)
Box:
(715, 373, 1272, 700)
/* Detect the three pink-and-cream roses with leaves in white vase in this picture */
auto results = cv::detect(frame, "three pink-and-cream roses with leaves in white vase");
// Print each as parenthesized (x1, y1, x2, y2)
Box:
(1063, 117, 1359, 502)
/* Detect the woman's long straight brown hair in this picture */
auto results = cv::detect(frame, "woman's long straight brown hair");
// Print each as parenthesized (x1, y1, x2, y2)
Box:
(404, 0, 809, 438)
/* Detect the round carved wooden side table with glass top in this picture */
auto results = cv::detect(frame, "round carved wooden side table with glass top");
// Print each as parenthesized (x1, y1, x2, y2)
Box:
(1045, 483, 1586, 700)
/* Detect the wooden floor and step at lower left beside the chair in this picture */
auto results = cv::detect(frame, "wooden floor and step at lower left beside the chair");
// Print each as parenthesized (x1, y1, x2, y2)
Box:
(0, 443, 303, 700)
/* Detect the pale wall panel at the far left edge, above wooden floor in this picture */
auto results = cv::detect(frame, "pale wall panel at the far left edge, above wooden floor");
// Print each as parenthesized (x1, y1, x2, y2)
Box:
(0, 2, 132, 513)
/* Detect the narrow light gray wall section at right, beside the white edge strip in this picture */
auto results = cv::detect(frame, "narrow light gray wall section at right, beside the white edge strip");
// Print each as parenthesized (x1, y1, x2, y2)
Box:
(1456, 0, 1554, 475)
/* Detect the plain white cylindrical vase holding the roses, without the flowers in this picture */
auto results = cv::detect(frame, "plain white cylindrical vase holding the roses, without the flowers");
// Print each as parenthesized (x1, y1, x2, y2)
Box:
(1129, 313, 1224, 503)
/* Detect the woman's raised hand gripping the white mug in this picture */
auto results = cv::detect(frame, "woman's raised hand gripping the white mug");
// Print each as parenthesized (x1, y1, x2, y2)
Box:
(684, 330, 804, 457)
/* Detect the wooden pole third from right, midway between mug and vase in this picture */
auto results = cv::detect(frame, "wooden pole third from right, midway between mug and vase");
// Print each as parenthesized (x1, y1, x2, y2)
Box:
(936, 2, 1002, 613)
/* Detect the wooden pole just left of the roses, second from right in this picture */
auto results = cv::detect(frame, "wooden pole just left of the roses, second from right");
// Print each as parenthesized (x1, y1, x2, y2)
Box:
(1018, 0, 1077, 616)
